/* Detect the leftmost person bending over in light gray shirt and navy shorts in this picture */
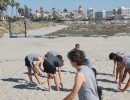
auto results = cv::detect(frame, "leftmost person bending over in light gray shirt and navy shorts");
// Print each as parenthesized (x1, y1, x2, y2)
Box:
(25, 53, 44, 84)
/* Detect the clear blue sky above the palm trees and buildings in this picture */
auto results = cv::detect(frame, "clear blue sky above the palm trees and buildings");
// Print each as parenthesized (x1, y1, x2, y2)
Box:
(9, 0, 130, 12)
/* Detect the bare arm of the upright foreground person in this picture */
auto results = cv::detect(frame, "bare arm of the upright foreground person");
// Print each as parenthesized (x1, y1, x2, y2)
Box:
(64, 73, 85, 100)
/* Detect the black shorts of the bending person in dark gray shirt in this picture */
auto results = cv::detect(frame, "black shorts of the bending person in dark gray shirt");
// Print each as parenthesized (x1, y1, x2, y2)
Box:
(43, 60, 56, 74)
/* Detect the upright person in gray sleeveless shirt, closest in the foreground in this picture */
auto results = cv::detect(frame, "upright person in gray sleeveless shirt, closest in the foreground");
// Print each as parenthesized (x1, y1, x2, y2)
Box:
(64, 50, 99, 100)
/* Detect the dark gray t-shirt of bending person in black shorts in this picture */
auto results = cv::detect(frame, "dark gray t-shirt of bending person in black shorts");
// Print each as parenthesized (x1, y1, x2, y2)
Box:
(47, 56, 62, 67)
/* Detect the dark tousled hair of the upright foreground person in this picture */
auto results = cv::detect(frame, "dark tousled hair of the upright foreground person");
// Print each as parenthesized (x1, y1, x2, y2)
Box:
(67, 49, 86, 66)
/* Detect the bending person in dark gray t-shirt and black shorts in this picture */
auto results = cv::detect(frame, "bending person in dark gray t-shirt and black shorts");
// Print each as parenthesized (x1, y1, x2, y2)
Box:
(43, 55, 63, 91)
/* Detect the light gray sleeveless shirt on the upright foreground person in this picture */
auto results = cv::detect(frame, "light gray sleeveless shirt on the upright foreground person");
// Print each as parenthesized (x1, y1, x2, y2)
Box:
(78, 66, 99, 100)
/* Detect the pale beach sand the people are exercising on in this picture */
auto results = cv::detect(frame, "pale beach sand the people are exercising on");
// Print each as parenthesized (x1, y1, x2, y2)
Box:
(0, 27, 130, 100)
